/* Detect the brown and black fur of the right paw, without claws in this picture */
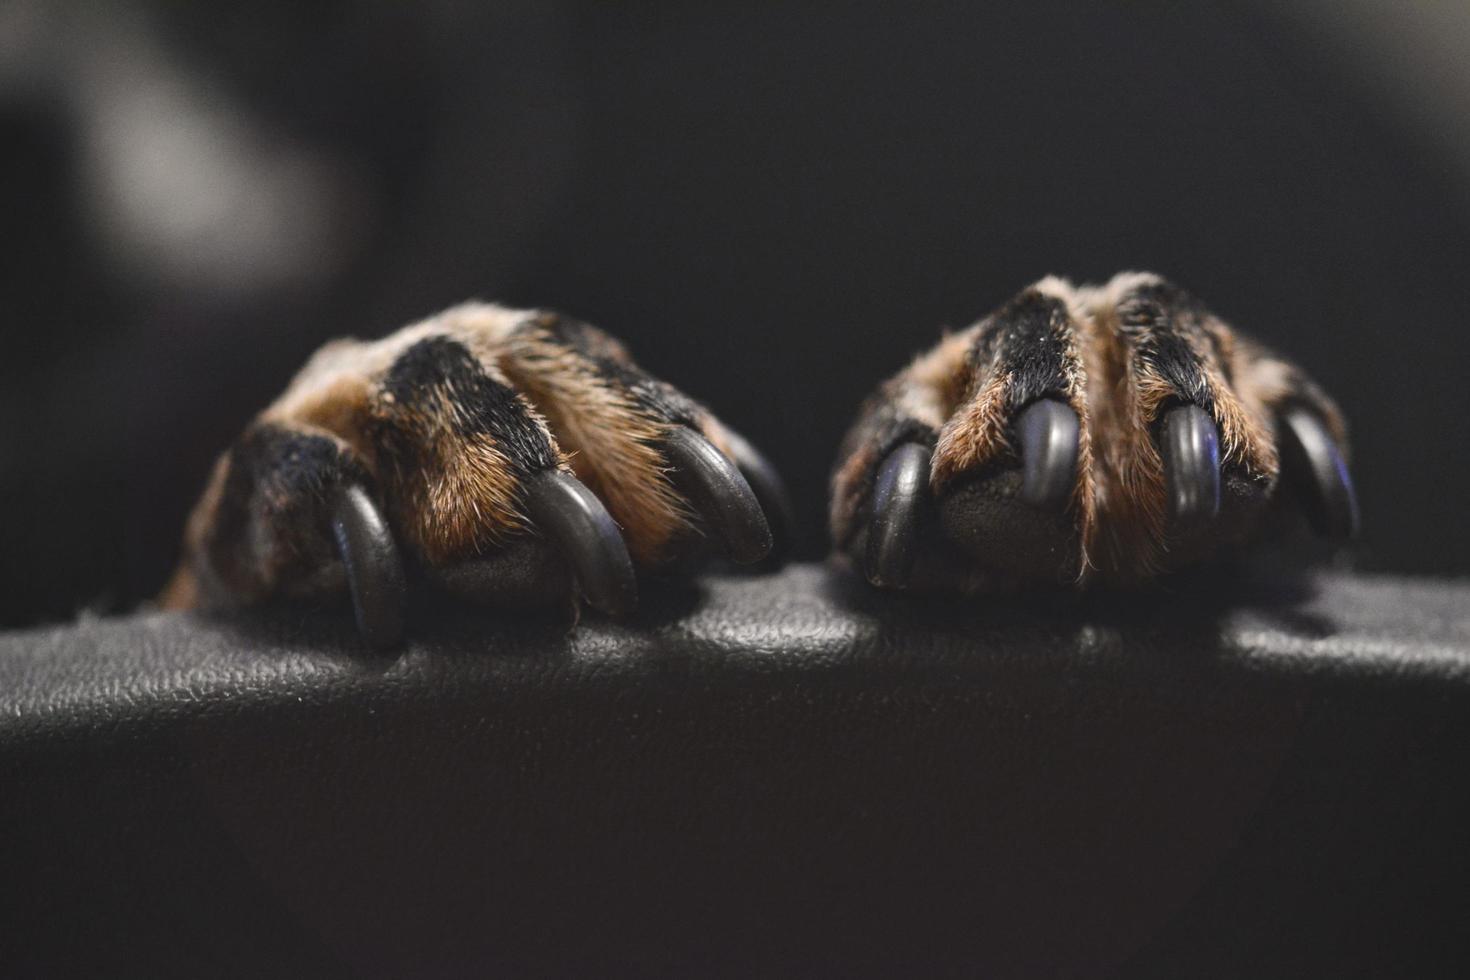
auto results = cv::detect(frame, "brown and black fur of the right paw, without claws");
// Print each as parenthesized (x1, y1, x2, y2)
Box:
(831, 273, 1347, 591)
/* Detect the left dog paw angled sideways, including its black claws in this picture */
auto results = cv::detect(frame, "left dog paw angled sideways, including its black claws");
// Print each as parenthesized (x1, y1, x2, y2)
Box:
(165, 304, 788, 644)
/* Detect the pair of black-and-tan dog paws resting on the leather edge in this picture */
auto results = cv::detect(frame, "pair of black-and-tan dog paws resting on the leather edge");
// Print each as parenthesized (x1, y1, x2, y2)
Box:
(163, 273, 1357, 644)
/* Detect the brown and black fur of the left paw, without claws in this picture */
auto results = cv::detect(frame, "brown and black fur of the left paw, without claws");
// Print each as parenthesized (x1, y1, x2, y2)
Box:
(162, 303, 752, 608)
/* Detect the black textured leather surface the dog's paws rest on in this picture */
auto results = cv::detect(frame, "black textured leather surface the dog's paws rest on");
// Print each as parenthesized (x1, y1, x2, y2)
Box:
(0, 566, 1470, 977)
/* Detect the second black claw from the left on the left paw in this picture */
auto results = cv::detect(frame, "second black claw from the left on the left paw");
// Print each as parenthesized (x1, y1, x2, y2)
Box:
(525, 470, 638, 616)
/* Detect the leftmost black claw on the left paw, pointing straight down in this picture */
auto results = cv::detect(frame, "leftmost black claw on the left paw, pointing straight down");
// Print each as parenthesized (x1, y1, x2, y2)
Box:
(332, 483, 407, 649)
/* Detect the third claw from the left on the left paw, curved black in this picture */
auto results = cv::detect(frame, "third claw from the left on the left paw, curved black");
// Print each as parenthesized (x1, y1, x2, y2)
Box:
(663, 426, 772, 564)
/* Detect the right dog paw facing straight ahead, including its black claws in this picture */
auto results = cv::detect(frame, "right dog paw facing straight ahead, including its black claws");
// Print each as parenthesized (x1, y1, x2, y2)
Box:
(832, 273, 1358, 591)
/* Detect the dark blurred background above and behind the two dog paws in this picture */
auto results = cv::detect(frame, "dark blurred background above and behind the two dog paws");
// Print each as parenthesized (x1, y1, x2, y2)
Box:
(0, 0, 1470, 626)
